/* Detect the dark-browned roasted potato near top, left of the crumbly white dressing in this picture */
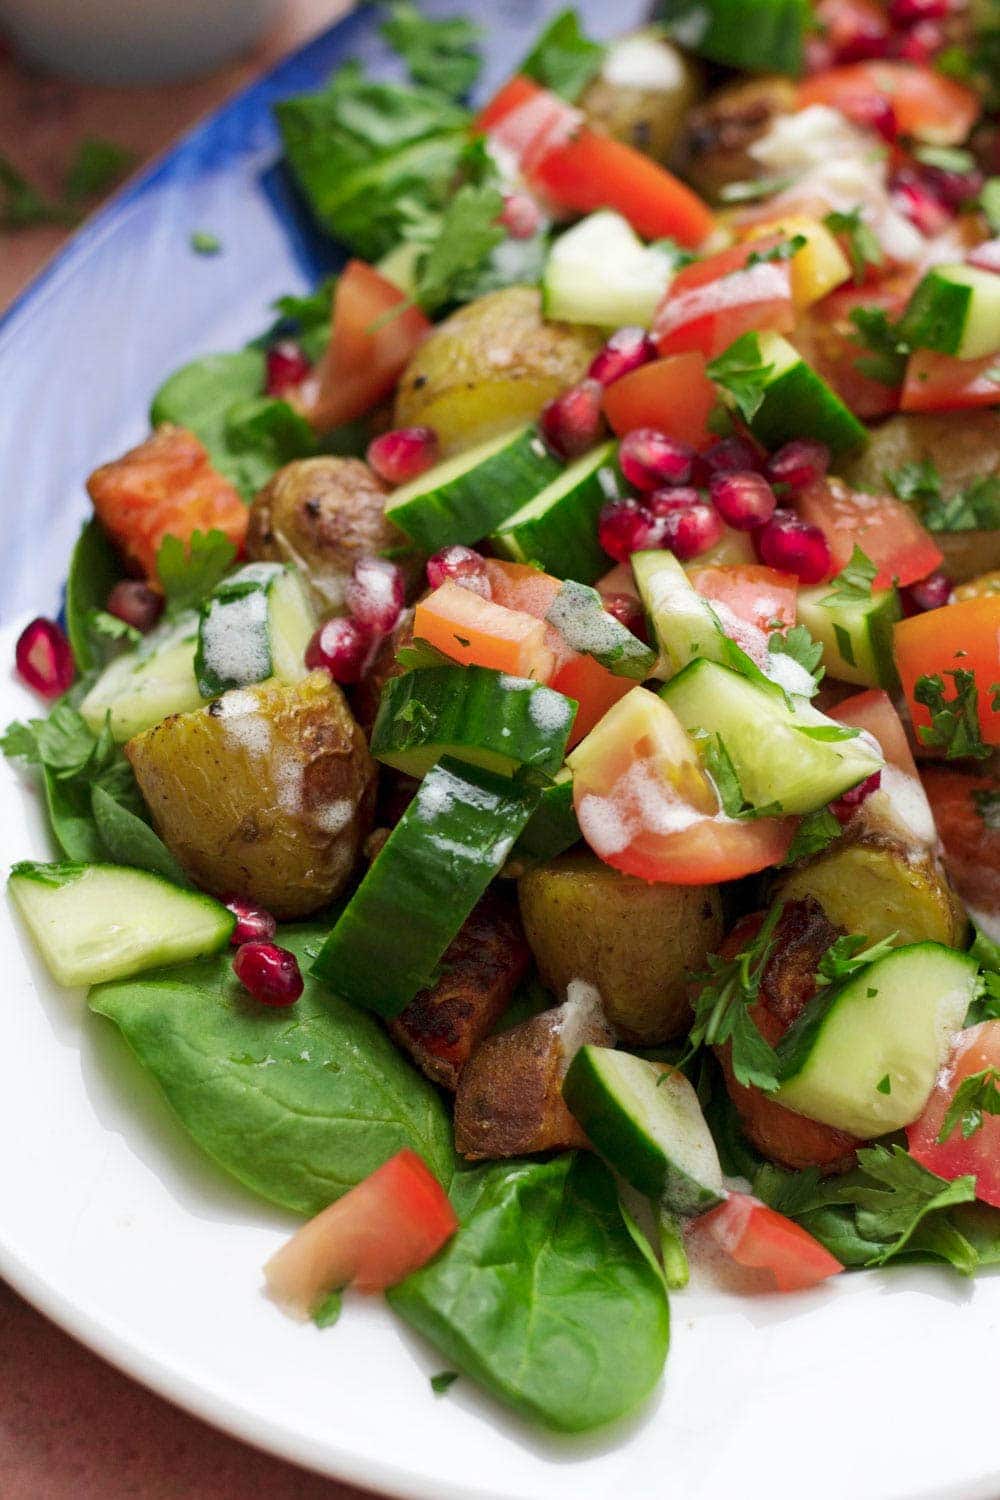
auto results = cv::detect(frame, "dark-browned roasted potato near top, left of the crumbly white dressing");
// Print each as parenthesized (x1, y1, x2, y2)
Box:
(673, 78, 795, 201)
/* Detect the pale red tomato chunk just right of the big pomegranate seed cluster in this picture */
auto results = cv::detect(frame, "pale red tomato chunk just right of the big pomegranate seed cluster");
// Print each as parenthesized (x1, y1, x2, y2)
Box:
(798, 479, 942, 588)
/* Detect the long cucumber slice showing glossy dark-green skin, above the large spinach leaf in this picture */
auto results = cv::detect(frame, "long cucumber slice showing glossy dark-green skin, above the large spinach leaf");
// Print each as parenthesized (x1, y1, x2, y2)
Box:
(312, 761, 538, 1017)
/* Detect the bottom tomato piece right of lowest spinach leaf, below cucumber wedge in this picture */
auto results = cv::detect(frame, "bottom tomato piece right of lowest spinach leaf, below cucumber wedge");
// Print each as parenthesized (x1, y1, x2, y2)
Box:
(696, 1193, 844, 1292)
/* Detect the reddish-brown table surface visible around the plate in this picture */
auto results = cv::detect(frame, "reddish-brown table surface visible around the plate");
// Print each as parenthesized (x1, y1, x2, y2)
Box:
(0, 0, 379, 1500)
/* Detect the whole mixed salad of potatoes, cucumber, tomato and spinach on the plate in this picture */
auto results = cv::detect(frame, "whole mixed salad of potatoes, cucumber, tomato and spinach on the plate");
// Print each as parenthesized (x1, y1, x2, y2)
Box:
(1, 0, 1000, 1433)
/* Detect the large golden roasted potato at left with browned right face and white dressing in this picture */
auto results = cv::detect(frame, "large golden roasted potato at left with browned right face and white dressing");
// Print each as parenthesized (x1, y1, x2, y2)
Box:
(124, 672, 376, 918)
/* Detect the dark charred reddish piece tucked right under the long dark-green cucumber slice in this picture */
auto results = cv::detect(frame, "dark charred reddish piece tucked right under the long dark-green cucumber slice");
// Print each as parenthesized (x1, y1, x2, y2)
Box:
(388, 887, 531, 1092)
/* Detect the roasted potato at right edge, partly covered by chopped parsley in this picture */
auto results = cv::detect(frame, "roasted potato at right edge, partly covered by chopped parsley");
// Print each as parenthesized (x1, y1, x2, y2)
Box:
(846, 411, 1000, 584)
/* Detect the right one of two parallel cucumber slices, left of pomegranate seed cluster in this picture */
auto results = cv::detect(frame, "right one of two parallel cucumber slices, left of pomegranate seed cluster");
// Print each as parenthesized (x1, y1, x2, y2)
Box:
(492, 443, 625, 584)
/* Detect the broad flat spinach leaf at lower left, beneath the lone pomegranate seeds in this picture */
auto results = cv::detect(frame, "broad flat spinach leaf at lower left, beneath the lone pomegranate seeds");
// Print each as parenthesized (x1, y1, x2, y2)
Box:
(90, 927, 454, 1215)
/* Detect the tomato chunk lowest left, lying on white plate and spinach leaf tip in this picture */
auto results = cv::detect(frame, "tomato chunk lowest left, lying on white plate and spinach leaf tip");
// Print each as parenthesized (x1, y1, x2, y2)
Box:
(264, 1151, 459, 1319)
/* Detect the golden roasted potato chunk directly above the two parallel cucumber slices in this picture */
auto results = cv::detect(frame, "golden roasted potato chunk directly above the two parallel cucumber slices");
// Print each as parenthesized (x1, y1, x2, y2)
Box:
(396, 287, 604, 452)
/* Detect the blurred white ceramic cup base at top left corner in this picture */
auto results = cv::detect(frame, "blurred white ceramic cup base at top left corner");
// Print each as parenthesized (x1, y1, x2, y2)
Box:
(0, 0, 282, 84)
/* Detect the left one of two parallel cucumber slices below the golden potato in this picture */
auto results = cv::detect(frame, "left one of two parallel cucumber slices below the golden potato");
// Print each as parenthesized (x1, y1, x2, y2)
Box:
(385, 428, 562, 552)
